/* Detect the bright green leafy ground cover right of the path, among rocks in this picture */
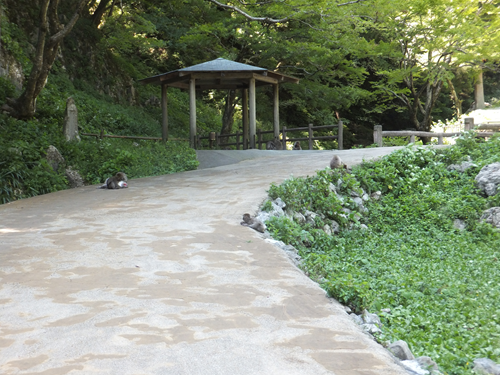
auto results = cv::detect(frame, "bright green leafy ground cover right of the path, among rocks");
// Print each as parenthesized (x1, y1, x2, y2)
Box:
(267, 135, 500, 375)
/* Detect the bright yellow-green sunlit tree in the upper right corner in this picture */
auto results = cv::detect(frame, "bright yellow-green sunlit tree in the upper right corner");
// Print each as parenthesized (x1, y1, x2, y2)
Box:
(377, 0, 500, 131)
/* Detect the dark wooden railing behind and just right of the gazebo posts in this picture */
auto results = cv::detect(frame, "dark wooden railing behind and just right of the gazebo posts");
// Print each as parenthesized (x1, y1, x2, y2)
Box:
(196, 121, 344, 150)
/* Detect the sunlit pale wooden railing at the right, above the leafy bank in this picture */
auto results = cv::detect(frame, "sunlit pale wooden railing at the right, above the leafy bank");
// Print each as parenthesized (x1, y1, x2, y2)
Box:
(373, 117, 500, 147)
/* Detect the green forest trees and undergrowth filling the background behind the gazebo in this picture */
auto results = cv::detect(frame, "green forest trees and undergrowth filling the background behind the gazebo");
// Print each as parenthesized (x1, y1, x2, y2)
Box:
(0, 0, 500, 202)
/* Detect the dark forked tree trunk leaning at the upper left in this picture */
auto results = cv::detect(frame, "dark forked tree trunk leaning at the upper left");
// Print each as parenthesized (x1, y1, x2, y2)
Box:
(11, 0, 88, 119)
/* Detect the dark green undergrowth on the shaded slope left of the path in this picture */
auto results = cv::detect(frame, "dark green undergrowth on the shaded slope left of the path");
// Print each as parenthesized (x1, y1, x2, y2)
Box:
(0, 77, 198, 204)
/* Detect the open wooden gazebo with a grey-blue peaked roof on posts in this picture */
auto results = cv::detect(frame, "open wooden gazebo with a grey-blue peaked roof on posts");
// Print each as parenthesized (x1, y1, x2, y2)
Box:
(141, 58, 299, 148)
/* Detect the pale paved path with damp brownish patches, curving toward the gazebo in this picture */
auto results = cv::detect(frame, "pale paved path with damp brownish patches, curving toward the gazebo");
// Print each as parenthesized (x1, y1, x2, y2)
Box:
(0, 148, 405, 375)
